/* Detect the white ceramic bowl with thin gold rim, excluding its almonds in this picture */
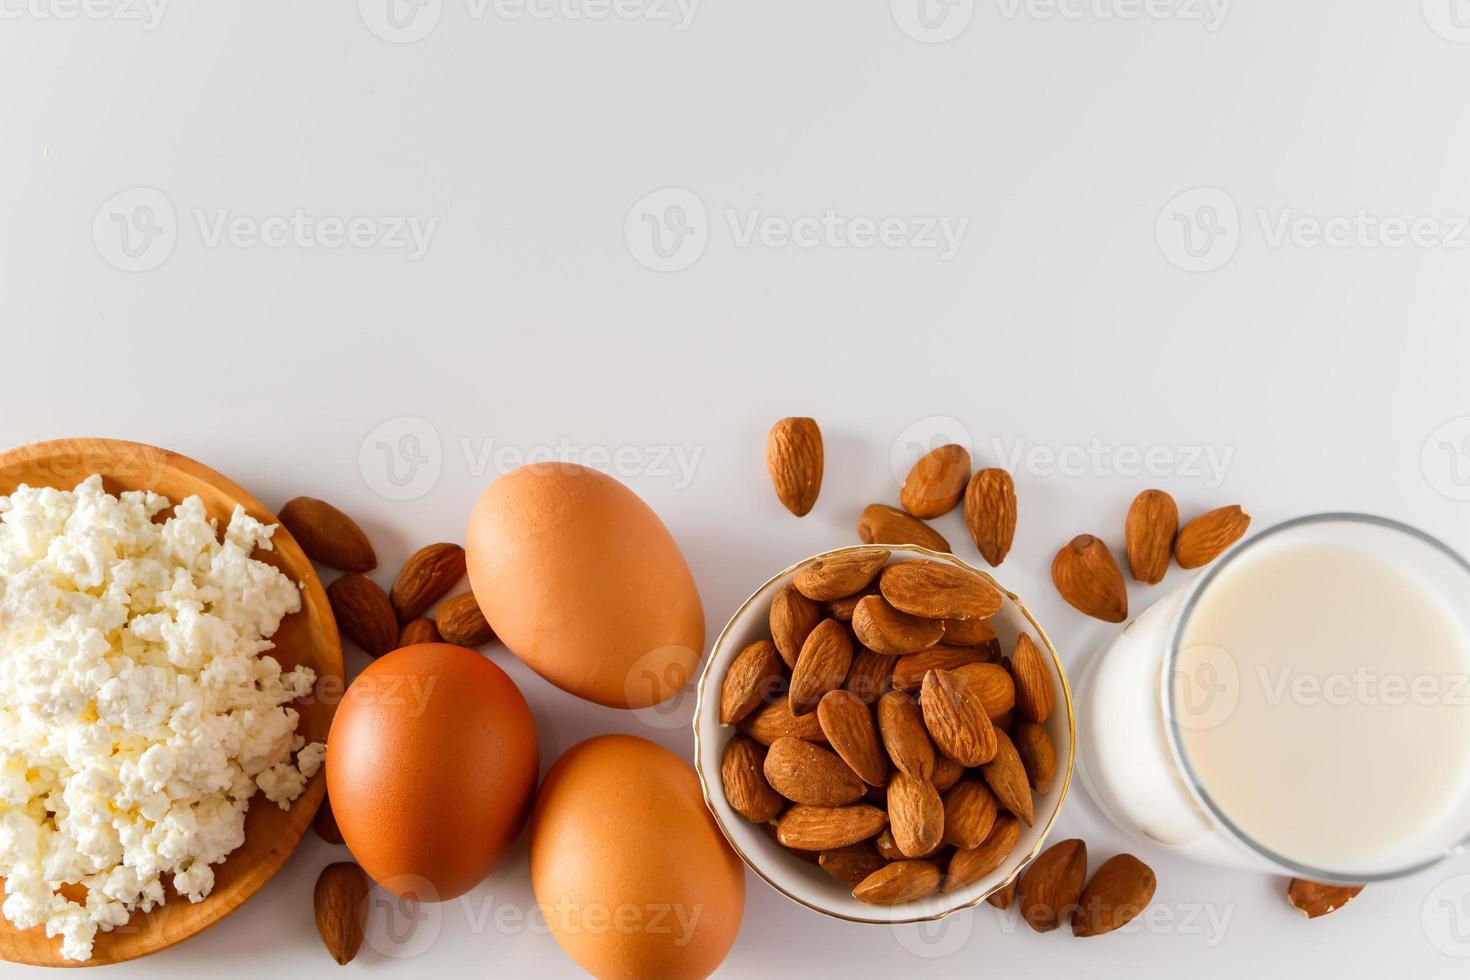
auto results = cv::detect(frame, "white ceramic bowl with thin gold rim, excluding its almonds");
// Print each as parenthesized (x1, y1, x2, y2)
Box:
(694, 545, 1076, 924)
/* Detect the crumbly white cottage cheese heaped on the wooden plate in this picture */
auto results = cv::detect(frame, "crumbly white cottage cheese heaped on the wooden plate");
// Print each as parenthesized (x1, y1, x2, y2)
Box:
(0, 476, 323, 959)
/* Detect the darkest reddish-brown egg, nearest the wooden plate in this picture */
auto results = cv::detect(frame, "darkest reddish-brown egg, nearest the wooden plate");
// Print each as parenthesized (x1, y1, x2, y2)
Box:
(326, 644, 538, 901)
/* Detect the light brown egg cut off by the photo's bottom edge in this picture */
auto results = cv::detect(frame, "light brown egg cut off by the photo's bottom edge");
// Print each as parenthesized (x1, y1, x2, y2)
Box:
(531, 735, 745, 980)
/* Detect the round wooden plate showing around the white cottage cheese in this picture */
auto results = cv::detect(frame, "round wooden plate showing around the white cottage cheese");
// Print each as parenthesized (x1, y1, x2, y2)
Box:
(0, 439, 343, 967)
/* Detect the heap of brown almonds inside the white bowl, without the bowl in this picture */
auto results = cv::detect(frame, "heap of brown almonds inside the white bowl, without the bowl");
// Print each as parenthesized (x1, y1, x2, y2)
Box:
(720, 548, 1057, 905)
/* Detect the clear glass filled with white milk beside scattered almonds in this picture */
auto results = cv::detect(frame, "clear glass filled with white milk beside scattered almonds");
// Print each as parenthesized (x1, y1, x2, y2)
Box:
(1078, 514, 1470, 883)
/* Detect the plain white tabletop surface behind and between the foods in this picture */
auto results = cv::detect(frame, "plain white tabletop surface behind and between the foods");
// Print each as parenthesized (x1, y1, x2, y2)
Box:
(0, 0, 1470, 977)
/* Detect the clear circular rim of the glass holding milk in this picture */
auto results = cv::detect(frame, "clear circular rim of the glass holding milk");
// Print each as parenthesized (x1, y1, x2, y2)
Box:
(1158, 511, 1470, 884)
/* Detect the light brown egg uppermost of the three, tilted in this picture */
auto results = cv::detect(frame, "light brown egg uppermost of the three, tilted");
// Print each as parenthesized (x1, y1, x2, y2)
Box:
(466, 463, 704, 708)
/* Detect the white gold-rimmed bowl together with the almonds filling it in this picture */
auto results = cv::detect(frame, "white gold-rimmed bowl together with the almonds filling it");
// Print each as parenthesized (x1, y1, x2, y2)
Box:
(694, 545, 1075, 923)
